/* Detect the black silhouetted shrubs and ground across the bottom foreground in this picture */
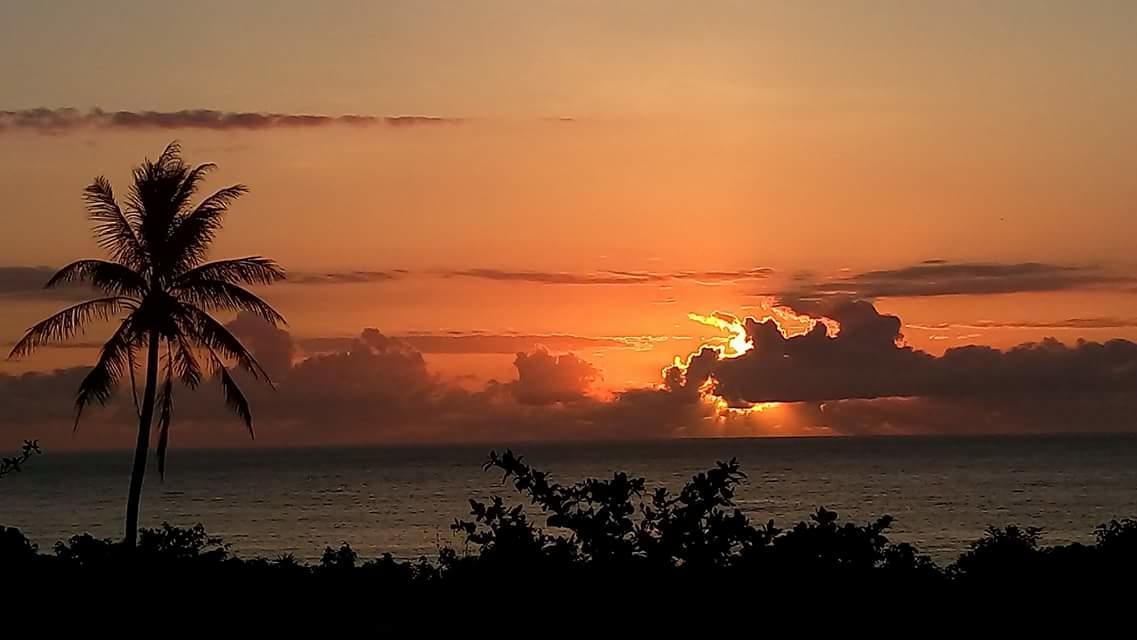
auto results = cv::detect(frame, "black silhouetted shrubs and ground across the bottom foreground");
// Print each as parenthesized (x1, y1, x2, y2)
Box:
(0, 451, 1137, 637)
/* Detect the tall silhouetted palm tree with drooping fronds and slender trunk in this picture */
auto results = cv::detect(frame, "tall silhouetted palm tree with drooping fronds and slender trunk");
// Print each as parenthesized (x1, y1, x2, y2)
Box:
(9, 142, 284, 548)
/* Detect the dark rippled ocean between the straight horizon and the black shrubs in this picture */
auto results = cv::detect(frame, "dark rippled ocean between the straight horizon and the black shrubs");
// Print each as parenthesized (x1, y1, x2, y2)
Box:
(0, 435, 1137, 563)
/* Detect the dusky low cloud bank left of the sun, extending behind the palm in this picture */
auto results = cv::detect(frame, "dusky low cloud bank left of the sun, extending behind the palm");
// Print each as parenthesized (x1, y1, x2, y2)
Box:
(0, 317, 713, 448)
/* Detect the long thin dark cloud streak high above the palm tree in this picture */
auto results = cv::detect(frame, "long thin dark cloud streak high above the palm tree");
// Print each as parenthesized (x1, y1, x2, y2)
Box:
(0, 107, 464, 134)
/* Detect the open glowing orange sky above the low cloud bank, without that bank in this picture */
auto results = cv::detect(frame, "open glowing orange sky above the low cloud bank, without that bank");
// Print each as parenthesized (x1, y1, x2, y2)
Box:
(0, 0, 1137, 447)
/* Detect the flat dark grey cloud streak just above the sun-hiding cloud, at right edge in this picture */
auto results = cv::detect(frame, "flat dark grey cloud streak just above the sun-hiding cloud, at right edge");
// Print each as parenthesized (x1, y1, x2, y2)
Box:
(782, 260, 1137, 301)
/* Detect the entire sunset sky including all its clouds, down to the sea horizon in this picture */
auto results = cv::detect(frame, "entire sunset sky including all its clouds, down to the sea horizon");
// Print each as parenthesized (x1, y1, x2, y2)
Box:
(0, 0, 1137, 447)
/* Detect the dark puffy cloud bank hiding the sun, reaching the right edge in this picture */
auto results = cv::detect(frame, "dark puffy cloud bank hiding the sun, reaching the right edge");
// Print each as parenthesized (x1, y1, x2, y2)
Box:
(669, 301, 1137, 433)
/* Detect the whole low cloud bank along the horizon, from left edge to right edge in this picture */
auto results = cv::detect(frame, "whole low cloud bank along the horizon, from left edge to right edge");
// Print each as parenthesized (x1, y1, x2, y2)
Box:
(0, 302, 1137, 444)
